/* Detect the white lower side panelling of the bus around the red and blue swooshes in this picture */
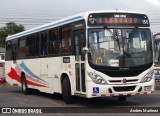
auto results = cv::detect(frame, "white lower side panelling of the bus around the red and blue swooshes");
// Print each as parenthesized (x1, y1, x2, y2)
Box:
(5, 57, 74, 93)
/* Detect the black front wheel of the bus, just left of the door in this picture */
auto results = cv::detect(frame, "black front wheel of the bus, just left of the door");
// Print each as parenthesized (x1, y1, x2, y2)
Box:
(62, 77, 74, 104)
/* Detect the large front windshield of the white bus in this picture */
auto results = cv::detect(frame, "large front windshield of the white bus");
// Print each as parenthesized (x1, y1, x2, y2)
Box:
(89, 28, 153, 67)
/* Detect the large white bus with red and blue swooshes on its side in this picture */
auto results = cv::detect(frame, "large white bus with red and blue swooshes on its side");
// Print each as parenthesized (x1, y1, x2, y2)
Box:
(5, 11, 155, 104)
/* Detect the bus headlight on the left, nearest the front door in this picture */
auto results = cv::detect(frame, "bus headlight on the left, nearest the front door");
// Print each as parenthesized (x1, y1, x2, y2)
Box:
(88, 72, 107, 84)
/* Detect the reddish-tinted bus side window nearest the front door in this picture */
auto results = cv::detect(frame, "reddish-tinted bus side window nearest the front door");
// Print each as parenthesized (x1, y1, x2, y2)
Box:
(61, 26, 71, 53)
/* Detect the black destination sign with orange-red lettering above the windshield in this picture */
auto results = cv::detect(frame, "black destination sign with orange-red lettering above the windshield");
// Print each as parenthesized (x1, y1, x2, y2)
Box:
(88, 13, 150, 27)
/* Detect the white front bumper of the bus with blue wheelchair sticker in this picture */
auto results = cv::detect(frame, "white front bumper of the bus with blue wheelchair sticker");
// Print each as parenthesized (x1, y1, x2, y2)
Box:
(87, 79, 154, 98)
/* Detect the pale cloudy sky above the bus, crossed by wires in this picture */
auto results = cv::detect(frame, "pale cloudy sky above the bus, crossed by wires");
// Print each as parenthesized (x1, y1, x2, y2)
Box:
(0, 0, 160, 34)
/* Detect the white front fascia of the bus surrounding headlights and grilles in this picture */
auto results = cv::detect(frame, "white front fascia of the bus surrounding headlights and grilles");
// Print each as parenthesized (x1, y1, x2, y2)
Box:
(86, 58, 155, 98)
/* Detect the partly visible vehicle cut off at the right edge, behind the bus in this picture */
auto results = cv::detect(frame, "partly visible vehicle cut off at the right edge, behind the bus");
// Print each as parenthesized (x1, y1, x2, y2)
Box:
(153, 33, 160, 80)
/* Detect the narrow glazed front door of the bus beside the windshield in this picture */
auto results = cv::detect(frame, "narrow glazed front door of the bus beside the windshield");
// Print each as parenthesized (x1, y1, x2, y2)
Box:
(73, 30, 86, 94)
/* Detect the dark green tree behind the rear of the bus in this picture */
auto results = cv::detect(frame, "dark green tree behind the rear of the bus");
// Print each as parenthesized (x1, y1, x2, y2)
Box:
(0, 22, 25, 47)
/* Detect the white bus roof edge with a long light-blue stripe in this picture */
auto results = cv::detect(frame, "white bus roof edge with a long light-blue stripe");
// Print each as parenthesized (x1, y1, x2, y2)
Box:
(6, 10, 144, 41)
